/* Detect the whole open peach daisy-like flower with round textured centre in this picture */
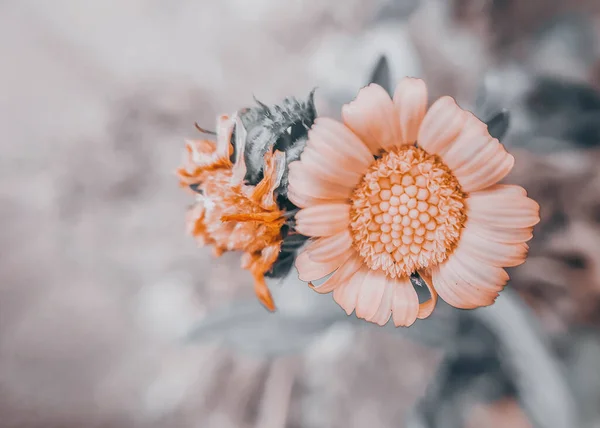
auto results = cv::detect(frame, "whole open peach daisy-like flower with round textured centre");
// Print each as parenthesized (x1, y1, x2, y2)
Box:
(288, 78, 539, 326)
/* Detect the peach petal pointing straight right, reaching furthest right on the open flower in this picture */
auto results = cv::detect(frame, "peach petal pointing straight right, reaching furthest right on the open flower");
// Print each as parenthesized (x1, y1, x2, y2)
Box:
(467, 185, 540, 229)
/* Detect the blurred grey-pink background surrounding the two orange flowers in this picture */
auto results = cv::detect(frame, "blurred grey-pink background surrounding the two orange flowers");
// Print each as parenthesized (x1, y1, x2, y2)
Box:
(0, 0, 600, 428)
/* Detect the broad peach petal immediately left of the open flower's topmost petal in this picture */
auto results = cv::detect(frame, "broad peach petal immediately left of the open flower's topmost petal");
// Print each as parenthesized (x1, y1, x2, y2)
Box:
(342, 83, 400, 154)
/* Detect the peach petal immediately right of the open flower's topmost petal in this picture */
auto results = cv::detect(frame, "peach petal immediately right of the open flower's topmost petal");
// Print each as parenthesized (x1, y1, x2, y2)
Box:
(417, 97, 467, 154)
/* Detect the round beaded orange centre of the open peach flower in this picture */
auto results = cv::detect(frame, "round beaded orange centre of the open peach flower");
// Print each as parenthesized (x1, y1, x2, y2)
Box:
(350, 146, 466, 278)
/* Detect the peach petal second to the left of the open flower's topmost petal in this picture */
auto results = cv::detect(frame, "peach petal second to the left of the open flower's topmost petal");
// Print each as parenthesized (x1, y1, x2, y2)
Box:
(306, 117, 373, 174)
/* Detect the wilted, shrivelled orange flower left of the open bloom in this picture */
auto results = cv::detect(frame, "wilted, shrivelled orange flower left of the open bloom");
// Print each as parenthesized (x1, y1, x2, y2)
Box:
(177, 116, 285, 310)
